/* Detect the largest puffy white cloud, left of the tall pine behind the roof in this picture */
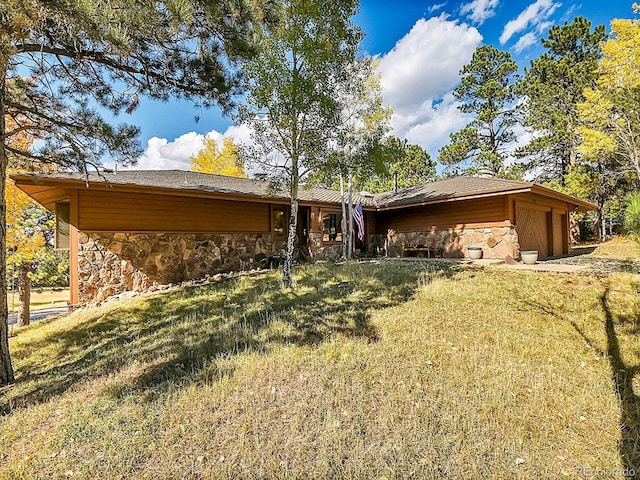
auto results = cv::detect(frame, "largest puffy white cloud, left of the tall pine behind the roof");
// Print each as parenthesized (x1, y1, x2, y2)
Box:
(380, 15, 482, 158)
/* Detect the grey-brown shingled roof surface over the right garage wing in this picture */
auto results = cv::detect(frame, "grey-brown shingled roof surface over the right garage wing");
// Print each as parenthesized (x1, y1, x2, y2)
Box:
(374, 177, 532, 207)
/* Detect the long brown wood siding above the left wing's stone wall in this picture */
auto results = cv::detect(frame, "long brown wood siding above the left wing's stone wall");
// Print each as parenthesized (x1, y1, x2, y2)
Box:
(78, 190, 271, 233)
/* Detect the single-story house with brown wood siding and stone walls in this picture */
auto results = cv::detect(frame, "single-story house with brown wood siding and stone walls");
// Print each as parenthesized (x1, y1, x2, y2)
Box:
(11, 170, 597, 305)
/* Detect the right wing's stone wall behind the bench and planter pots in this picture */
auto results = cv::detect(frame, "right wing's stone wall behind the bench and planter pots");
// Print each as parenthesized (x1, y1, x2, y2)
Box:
(378, 227, 520, 259)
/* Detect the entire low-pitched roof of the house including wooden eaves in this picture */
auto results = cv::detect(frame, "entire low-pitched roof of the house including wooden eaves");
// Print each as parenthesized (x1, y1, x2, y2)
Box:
(11, 170, 598, 210)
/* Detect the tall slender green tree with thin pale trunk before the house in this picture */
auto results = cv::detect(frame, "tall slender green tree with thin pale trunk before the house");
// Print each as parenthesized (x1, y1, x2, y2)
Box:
(238, 0, 362, 286)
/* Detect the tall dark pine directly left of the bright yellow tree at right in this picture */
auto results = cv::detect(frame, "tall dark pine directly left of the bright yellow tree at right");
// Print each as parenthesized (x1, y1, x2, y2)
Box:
(517, 17, 605, 184)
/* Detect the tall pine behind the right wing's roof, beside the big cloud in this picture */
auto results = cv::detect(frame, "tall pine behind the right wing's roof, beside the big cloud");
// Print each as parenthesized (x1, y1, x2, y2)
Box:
(438, 45, 518, 177)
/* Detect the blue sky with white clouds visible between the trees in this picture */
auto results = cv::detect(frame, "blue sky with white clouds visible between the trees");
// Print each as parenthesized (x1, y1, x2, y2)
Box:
(120, 0, 633, 169)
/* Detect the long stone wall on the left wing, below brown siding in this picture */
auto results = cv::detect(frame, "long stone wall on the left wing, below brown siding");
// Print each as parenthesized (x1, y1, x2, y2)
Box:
(78, 232, 284, 305)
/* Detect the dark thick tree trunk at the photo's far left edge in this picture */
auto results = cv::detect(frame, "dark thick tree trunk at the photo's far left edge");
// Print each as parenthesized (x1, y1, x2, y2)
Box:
(0, 62, 14, 386)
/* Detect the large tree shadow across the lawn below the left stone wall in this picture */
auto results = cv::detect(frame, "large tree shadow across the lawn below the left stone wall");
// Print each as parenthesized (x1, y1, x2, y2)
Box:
(0, 264, 440, 412)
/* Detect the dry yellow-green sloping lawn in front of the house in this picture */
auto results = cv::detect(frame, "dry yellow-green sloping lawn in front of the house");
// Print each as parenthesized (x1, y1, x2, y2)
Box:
(0, 242, 640, 479)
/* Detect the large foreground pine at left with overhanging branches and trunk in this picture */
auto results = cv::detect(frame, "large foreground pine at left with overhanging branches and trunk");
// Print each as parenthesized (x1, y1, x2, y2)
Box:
(0, 0, 271, 385)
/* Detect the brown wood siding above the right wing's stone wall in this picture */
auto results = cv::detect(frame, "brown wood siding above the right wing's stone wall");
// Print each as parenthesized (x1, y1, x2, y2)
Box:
(377, 197, 506, 232)
